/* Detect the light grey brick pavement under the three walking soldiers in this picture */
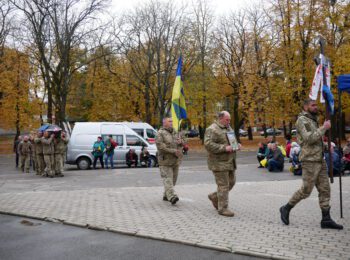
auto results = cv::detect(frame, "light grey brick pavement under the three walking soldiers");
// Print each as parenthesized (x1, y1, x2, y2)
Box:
(0, 178, 350, 259)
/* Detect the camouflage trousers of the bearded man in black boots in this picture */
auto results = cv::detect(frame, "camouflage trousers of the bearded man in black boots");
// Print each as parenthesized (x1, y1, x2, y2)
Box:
(289, 161, 331, 209)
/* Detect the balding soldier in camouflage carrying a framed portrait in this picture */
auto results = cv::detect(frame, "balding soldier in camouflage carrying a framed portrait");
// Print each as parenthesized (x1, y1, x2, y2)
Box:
(204, 111, 236, 217)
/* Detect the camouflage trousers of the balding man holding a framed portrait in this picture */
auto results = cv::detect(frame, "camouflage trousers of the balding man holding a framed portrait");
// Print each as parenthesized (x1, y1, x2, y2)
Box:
(209, 171, 236, 211)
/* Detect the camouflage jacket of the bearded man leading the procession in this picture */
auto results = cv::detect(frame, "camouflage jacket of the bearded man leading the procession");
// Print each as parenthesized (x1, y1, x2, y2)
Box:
(296, 111, 326, 162)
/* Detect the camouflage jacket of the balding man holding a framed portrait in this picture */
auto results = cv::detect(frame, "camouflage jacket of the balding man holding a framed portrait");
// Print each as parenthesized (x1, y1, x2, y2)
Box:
(204, 122, 236, 171)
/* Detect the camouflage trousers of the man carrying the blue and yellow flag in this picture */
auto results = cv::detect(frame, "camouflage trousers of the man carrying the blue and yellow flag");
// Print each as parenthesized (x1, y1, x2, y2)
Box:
(159, 165, 179, 200)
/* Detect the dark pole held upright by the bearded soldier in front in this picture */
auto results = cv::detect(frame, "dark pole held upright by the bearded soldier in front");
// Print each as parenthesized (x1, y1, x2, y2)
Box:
(319, 36, 334, 183)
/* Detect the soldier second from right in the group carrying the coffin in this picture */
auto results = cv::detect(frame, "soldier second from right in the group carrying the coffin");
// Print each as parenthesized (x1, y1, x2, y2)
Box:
(41, 131, 55, 178)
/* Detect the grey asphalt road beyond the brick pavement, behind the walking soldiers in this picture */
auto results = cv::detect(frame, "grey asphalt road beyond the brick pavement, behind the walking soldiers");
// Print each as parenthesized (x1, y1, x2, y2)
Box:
(0, 152, 300, 192)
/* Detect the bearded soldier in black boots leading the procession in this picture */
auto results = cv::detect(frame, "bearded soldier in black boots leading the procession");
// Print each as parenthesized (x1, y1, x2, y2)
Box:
(280, 99, 343, 229)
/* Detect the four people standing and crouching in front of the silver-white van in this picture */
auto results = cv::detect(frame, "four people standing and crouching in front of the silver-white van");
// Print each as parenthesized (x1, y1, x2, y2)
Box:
(92, 135, 152, 169)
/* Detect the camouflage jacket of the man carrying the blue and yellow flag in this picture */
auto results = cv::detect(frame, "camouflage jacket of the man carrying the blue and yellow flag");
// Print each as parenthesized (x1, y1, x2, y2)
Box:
(156, 127, 182, 166)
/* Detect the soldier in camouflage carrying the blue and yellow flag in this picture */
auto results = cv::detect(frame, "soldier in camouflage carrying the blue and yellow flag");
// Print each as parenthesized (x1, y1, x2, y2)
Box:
(156, 117, 184, 205)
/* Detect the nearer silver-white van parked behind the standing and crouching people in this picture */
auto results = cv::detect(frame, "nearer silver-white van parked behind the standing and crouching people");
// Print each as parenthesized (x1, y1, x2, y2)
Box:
(66, 122, 157, 170)
